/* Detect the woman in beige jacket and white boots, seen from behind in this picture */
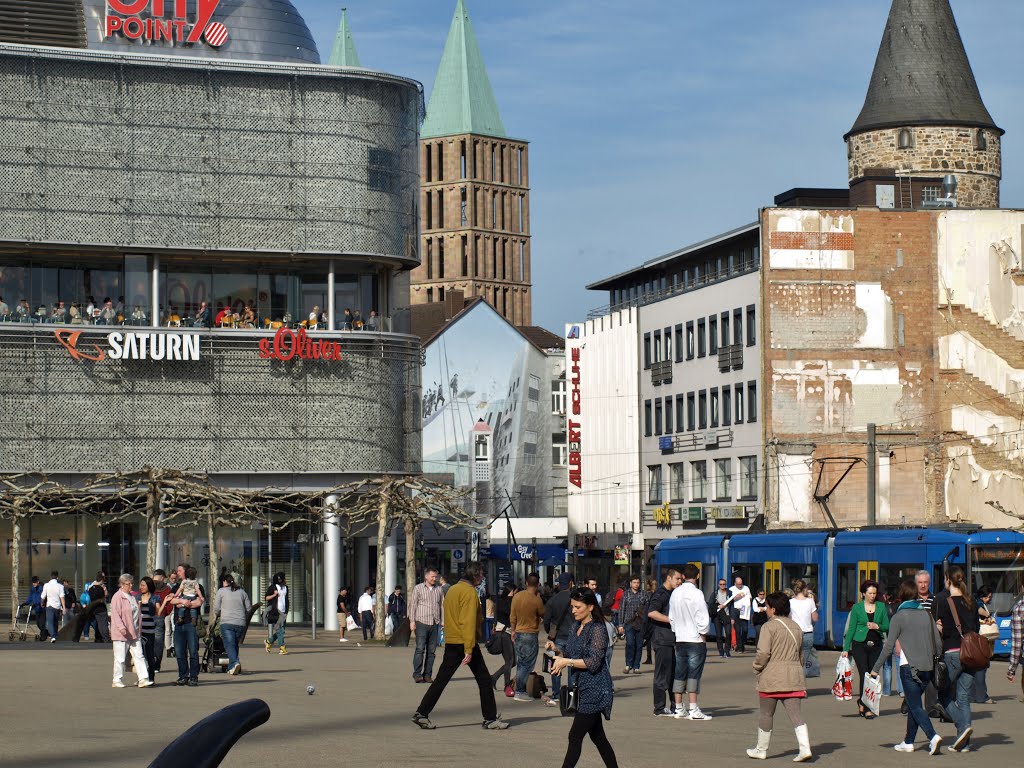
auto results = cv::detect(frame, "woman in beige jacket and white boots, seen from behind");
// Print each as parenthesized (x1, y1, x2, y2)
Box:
(746, 592, 811, 763)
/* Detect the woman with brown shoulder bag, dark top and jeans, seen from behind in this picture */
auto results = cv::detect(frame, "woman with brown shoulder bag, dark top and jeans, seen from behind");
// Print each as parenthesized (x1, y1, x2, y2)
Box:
(935, 565, 980, 752)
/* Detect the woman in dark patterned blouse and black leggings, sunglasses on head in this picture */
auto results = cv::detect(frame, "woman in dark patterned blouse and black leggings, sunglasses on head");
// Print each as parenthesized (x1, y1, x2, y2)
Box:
(552, 589, 618, 768)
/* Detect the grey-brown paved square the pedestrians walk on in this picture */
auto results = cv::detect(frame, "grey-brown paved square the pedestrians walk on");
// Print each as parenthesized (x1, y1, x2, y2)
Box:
(0, 628, 1024, 768)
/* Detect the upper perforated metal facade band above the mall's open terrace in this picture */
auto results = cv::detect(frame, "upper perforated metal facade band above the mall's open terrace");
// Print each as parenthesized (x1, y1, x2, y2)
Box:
(0, 45, 422, 263)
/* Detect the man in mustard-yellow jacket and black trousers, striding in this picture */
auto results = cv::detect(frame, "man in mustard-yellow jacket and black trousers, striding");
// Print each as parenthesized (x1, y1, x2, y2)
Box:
(405, 561, 508, 730)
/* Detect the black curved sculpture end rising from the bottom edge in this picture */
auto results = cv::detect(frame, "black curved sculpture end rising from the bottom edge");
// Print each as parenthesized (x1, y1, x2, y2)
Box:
(150, 698, 270, 768)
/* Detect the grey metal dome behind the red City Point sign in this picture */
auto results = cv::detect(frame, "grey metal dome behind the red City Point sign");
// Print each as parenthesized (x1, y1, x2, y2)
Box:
(82, 0, 319, 63)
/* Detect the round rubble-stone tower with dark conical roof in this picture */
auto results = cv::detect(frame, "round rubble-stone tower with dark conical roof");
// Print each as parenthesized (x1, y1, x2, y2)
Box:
(845, 0, 1004, 208)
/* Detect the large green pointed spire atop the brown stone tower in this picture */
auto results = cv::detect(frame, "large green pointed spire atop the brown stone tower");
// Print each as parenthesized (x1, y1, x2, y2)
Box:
(420, 0, 507, 138)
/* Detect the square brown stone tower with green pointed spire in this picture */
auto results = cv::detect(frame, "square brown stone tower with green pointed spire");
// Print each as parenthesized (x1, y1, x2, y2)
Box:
(411, 0, 531, 326)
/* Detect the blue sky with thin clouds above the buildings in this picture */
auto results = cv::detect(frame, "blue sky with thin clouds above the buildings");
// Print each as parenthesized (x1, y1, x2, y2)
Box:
(293, 0, 1024, 333)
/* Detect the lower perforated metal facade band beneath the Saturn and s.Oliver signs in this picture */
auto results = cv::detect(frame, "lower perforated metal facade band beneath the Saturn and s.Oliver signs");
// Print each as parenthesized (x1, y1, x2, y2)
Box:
(0, 325, 422, 484)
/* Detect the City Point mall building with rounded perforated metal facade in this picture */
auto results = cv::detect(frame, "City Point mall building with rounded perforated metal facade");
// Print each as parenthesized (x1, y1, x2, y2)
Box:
(0, 0, 423, 622)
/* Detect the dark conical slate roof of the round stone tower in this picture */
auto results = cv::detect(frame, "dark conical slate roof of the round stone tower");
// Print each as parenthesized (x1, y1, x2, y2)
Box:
(847, 0, 1004, 137)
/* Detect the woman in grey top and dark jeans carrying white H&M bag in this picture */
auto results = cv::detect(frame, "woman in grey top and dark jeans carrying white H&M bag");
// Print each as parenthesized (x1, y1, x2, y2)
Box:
(871, 579, 942, 755)
